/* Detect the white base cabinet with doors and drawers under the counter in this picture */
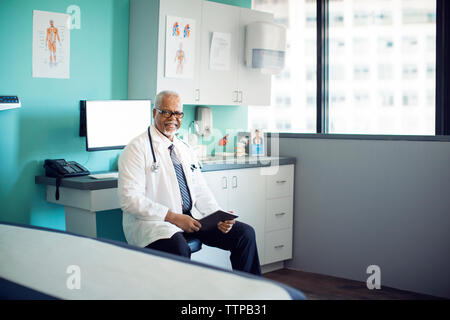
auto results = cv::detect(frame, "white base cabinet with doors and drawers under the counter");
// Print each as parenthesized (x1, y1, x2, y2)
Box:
(192, 165, 294, 269)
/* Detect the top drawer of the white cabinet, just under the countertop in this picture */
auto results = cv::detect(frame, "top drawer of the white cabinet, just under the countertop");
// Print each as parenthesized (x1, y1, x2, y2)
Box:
(266, 165, 294, 199)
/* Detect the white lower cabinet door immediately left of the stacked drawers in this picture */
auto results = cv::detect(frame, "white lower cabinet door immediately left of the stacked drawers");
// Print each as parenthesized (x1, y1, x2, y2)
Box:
(228, 168, 266, 263)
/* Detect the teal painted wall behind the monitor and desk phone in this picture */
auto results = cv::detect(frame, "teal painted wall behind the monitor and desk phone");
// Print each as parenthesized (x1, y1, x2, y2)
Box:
(0, 0, 251, 240)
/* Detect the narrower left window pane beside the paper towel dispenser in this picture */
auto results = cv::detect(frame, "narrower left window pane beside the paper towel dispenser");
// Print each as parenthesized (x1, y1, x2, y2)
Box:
(248, 0, 318, 133)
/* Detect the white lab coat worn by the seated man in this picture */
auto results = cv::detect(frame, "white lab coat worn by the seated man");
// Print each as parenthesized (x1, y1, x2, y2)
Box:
(118, 126, 220, 247)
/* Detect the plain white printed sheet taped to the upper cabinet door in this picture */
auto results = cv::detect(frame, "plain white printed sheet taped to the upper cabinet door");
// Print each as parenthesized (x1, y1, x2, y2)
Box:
(209, 32, 231, 71)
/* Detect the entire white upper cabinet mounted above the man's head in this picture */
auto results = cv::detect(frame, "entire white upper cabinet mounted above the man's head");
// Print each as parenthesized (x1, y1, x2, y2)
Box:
(128, 0, 273, 105)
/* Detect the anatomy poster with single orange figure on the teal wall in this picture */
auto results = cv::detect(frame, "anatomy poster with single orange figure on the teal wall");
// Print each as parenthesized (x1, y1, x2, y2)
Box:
(33, 10, 71, 79)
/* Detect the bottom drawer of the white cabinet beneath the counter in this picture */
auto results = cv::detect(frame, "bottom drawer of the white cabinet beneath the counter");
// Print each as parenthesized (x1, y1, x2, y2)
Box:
(264, 228, 292, 264)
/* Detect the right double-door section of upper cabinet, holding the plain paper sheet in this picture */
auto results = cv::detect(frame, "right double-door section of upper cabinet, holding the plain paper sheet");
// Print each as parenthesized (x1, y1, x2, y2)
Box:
(199, 1, 273, 105)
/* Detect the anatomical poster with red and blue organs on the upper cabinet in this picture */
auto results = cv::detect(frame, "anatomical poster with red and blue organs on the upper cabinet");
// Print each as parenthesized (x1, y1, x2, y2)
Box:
(165, 16, 197, 79)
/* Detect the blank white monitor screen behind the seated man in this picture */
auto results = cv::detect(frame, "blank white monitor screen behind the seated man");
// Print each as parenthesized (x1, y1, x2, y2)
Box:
(85, 100, 151, 151)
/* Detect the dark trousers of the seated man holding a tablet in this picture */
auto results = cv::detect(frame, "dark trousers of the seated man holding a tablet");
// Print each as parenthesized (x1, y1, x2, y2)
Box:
(147, 221, 261, 275)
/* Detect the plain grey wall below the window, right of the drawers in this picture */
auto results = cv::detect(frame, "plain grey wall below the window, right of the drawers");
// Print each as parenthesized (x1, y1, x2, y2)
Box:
(280, 138, 450, 298)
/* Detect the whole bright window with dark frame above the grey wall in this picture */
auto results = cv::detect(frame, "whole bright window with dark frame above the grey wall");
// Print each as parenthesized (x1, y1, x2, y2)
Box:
(249, 0, 444, 135)
